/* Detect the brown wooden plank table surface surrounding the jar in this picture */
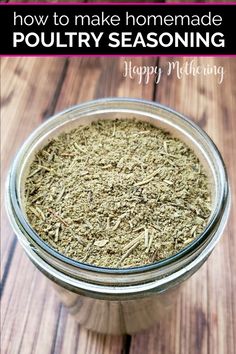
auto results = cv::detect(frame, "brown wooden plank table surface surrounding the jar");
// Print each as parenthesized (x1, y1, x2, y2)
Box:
(1, 57, 236, 354)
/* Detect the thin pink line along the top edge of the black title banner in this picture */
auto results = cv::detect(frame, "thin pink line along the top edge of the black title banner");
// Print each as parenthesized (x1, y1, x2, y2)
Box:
(0, 1, 236, 6)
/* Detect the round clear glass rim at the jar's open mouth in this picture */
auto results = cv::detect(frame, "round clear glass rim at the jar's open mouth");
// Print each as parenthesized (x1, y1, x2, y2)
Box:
(7, 98, 229, 275)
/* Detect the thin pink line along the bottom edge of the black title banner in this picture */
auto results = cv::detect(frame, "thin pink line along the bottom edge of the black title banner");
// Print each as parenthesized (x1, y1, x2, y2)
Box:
(0, 53, 236, 58)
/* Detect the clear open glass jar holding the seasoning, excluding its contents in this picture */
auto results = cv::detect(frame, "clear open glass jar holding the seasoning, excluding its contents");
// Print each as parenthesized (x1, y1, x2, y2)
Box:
(6, 98, 230, 334)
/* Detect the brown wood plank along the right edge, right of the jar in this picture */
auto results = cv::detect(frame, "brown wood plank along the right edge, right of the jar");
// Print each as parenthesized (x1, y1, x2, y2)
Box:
(131, 58, 236, 354)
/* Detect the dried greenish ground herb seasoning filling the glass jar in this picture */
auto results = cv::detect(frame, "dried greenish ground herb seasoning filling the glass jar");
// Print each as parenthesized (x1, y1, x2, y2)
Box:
(25, 120, 211, 267)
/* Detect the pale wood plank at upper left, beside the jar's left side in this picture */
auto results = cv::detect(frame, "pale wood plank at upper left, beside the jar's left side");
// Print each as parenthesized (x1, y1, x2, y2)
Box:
(1, 58, 65, 274)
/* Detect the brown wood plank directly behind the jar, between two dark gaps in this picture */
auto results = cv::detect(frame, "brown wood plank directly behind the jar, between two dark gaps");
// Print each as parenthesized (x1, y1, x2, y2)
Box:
(56, 57, 156, 111)
